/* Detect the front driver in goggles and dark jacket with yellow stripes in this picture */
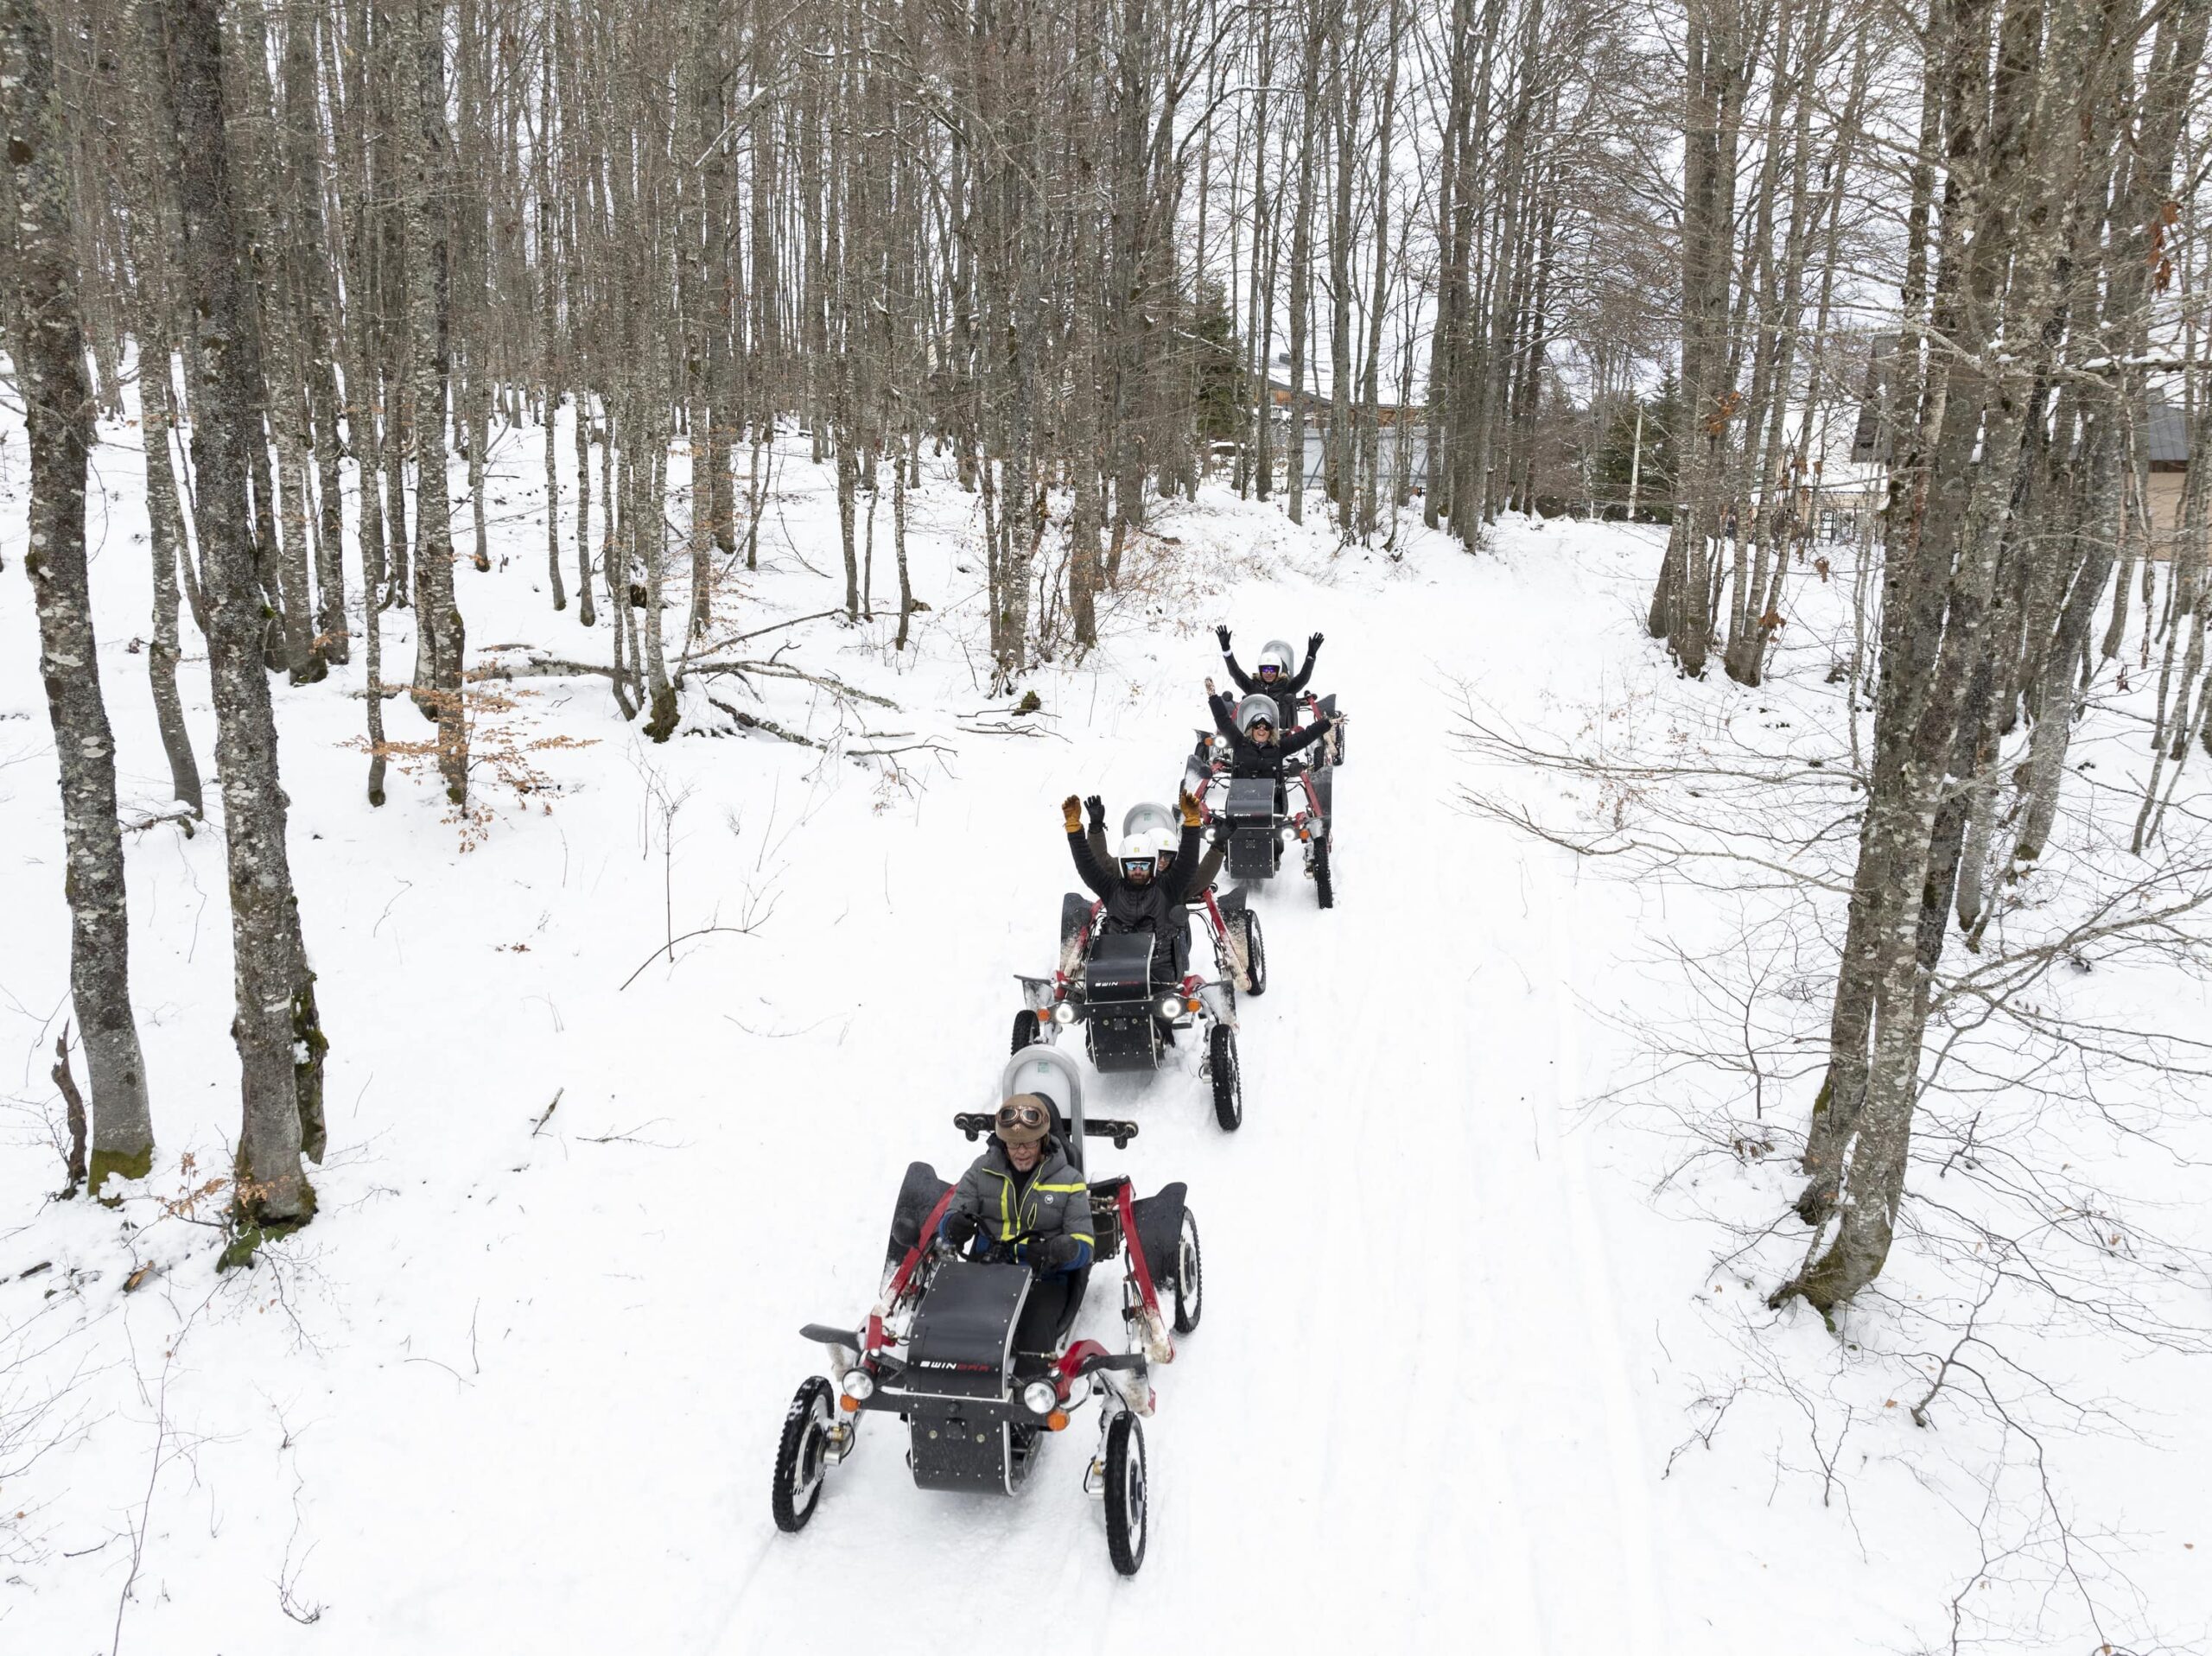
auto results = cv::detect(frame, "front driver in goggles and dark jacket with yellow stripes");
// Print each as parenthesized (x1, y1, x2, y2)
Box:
(938, 1092, 1095, 1353)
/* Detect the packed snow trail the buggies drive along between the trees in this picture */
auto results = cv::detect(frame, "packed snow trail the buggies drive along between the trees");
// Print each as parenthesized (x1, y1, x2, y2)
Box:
(715, 512, 1662, 1656)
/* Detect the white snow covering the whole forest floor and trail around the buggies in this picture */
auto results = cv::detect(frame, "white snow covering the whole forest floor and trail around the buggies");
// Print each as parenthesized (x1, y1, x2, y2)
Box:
(0, 406, 2212, 1656)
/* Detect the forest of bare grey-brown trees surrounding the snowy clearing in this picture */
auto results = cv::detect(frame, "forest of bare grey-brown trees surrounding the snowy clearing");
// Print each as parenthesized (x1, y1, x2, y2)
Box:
(4, 0, 2212, 1309)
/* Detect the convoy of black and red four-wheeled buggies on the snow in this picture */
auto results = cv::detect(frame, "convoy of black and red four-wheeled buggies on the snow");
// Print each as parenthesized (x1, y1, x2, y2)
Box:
(770, 628, 1344, 1577)
